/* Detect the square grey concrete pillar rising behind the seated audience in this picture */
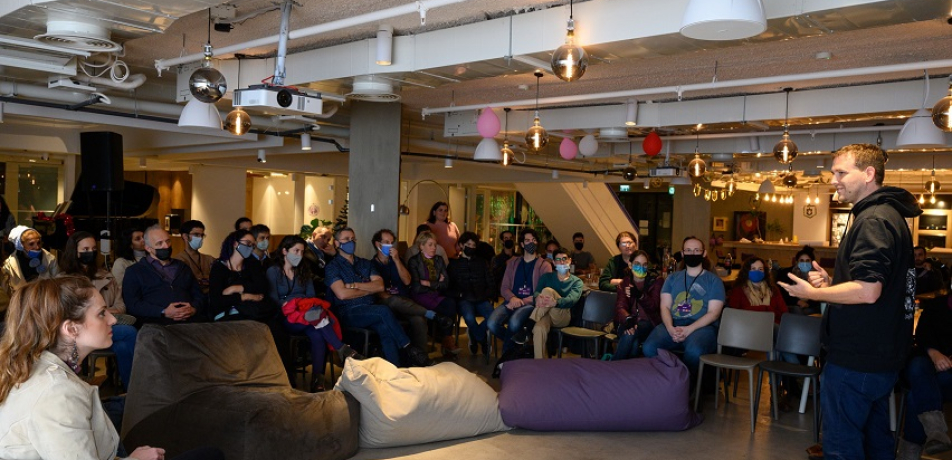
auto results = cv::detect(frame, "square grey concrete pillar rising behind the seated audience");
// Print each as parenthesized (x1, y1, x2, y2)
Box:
(347, 101, 400, 258)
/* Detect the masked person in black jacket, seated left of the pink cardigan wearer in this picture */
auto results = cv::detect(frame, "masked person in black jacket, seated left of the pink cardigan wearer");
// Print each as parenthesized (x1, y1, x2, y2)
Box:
(447, 232, 496, 355)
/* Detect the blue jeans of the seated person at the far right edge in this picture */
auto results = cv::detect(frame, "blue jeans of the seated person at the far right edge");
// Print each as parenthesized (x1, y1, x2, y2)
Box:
(902, 355, 952, 444)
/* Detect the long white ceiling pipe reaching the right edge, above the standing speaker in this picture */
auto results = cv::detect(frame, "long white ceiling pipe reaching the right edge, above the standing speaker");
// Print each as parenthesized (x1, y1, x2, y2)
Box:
(422, 59, 952, 118)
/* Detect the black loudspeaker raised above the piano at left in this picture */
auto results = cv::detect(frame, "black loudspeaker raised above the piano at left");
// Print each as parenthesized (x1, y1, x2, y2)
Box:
(79, 131, 125, 192)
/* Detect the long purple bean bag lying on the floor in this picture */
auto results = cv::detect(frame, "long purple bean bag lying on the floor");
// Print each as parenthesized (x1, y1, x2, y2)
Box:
(499, 350, 701, 431)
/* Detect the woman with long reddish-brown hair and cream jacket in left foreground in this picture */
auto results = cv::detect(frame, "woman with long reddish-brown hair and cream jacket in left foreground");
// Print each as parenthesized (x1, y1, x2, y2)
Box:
(0, 276, 224, 460)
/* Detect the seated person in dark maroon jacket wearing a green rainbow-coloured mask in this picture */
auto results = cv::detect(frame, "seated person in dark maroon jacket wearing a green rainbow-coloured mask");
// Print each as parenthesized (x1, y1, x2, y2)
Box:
(612, 251, 664, 361)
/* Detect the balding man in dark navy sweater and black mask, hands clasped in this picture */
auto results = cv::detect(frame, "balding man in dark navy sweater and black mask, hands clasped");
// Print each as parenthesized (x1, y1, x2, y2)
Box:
(122, 225, 205, 325)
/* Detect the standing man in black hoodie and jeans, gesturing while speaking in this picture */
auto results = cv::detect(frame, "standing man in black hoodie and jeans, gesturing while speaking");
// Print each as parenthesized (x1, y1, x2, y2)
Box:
(781, 144, 922, 460)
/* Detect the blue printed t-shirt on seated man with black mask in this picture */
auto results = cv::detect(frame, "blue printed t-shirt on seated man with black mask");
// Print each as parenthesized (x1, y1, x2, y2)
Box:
(661, 270, 725, 326)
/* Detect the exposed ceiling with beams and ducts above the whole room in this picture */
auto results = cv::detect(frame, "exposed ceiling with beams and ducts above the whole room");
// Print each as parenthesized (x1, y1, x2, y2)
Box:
(0, 0, 952, 189)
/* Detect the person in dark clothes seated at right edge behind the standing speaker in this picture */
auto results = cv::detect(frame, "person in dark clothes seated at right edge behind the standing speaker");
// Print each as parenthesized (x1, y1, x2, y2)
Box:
(896, 305, 952, 460)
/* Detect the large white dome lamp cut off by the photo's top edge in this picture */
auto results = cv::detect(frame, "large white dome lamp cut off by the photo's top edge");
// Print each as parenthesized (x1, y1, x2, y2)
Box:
(681, 0, 767, 40)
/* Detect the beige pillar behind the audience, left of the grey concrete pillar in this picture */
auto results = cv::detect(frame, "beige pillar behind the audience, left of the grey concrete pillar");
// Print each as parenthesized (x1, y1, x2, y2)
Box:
(189, 165, 245, 254)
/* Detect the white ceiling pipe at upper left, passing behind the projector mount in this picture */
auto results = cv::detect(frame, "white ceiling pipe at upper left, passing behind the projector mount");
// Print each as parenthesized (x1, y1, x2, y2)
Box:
(155, 0, 466, 72)
